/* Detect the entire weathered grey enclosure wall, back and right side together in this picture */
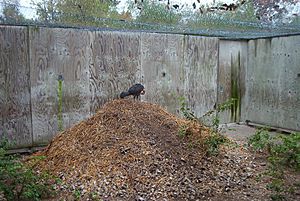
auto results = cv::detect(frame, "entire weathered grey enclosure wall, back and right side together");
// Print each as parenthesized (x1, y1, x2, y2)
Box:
(0, 26, 300, 148)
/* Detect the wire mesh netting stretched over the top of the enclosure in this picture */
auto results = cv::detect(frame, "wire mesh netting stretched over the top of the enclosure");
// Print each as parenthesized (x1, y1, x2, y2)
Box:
(0, 0, 300, 39)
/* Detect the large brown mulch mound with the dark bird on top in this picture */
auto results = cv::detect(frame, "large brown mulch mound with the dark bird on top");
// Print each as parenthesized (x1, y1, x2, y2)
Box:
(30, 99, 270, 200)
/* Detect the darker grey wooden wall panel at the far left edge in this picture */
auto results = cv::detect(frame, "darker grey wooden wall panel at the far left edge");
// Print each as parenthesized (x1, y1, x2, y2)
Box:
(0, 26, 32, 148)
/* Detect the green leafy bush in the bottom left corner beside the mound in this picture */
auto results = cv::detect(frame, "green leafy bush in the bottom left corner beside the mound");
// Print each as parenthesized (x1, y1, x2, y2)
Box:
(0, 141, 54, 201)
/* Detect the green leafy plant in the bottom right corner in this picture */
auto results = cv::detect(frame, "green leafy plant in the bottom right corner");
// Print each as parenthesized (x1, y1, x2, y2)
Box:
(248, 129, 300, 200)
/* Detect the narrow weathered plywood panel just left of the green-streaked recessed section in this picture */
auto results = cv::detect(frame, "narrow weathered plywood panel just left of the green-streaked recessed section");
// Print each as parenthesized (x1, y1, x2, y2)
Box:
(184, 36, 219, 117)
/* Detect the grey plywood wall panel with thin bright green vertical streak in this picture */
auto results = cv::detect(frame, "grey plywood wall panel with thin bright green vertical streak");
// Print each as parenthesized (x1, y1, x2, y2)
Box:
(30, 28, 93, 145)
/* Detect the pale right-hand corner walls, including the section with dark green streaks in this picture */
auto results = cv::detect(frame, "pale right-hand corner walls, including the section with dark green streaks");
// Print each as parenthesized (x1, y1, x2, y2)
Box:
(218, 36, 300, 131)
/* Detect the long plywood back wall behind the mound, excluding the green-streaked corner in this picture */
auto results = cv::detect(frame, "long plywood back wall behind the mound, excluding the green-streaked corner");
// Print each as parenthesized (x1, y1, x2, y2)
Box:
(0, 26, 219, 148)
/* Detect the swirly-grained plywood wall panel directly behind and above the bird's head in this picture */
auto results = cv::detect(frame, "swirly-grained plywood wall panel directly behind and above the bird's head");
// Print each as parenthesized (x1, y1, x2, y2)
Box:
(90, 31, 141, 113)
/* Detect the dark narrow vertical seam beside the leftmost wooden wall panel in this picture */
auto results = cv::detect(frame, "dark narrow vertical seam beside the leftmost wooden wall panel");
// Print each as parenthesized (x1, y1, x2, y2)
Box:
(27, 25, 34, 147)
